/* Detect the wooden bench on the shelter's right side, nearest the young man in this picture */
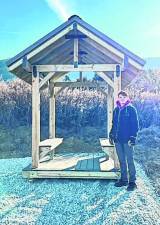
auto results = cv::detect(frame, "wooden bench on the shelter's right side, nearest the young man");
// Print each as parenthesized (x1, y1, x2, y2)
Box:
(99, 138, 120, 169)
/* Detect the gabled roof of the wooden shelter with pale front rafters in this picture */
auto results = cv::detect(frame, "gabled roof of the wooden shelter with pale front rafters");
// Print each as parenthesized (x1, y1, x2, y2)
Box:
(7, 15, 145, 85)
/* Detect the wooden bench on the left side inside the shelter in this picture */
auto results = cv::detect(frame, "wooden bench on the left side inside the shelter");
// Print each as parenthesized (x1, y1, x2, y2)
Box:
(39, 138, 63, 163)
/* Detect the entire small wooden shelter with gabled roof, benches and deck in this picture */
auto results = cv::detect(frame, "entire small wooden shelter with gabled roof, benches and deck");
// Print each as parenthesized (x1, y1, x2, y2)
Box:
(7, 15, 145, 179)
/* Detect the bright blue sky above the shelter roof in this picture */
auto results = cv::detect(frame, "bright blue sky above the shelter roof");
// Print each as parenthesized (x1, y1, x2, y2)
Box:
(0, 0, 160, 59)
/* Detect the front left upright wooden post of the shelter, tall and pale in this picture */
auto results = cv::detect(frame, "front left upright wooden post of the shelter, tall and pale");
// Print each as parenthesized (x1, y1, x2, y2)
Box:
(32, 66, 40, 168)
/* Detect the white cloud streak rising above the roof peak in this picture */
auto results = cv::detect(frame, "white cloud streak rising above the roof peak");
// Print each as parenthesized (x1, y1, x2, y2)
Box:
(46, 0, 71, 21)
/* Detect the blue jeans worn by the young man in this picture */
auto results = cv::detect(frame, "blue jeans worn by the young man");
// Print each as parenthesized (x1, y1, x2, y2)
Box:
(115, 142, 136, 182)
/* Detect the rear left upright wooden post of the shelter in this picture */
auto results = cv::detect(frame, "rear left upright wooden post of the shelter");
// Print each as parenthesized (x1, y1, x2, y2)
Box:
(49, 83, 56, 138)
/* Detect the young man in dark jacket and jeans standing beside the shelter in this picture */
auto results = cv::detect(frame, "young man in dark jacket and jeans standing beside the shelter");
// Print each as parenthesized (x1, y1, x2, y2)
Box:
(109, 91, 139, 191)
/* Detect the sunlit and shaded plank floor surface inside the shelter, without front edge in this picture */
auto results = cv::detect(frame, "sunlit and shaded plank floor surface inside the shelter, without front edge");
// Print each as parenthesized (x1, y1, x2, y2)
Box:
(37, 152, 114, 171)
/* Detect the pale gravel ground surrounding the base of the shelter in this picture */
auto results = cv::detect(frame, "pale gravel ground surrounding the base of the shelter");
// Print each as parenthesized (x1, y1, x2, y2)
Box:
(0, 158, 160, 225)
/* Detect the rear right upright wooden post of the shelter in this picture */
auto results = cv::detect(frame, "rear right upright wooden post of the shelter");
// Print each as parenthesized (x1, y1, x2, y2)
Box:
(107, 85, 113, 138)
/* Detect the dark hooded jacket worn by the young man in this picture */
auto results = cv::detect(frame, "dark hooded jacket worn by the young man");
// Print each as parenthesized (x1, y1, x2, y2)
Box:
(110, 100, 139, 143)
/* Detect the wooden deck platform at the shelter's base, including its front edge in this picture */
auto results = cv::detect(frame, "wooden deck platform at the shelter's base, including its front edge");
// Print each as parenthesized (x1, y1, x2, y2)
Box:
(22, 152, 119, 179)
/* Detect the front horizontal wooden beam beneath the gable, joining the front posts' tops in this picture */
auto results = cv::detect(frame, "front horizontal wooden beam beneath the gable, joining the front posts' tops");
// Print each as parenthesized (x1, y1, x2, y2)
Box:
(37, 64, 116, 72)
